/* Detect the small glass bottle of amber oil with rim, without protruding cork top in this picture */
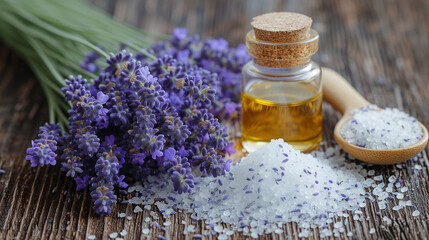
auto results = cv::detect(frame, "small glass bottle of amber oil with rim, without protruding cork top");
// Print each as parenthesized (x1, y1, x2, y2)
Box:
(241, 29, 322, 152)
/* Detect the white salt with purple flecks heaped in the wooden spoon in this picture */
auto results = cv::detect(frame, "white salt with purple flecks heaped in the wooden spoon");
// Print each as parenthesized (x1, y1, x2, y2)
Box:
(341, 105, 423, 149)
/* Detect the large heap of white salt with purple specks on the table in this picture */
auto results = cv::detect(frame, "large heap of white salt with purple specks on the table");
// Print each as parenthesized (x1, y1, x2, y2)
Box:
(122, 140, 419, 239)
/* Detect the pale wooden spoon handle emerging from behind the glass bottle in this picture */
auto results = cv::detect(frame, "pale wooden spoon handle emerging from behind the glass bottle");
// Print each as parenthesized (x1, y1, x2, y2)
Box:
(322, 67, 370, 114)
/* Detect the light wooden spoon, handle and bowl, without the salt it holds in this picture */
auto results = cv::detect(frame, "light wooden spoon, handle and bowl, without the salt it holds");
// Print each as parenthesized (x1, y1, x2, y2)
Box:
(322, 68, 428, 165)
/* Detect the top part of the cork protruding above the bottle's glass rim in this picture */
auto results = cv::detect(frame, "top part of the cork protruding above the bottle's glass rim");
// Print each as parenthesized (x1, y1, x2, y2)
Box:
(251, 12, 312, 43)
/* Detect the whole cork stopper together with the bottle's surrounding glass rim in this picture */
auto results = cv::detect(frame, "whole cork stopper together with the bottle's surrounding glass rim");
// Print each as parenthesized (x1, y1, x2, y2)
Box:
(246, 12, 319, 68)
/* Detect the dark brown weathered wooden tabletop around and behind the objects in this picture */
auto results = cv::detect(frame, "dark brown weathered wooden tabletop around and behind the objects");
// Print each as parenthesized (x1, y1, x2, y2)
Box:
(0, 0, 429, 239)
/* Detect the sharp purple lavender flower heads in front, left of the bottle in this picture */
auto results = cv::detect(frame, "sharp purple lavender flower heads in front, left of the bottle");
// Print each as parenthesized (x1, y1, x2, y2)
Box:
(27, 48, 236, 215)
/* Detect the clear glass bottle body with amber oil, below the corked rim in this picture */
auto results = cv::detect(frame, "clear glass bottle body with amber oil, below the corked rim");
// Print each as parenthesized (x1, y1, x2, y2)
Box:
(241, 59, 322, 152)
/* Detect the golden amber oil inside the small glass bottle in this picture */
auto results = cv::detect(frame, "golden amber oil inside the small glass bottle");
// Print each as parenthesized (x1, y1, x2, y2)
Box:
(241, 81, 322, 152)
